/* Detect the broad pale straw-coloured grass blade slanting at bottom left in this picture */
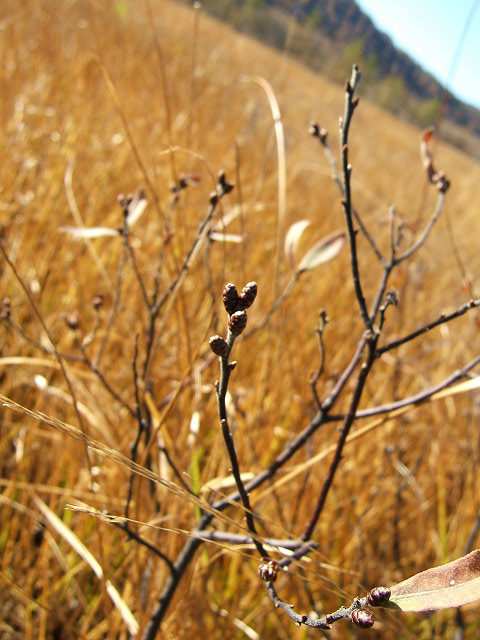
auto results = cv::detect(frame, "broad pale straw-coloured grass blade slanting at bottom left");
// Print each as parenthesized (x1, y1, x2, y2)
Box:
(32, 492, 140, 636)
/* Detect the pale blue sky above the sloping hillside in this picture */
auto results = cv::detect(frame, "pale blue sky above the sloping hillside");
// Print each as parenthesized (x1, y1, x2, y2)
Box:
(356, 0, 480, 108)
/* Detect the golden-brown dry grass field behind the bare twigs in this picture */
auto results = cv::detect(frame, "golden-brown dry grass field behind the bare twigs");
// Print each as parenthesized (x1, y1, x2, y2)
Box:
(0, 0, 480, 640)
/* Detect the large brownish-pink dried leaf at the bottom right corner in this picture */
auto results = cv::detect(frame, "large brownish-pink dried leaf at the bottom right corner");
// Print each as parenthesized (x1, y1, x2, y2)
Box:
(385, 549, 480, 611)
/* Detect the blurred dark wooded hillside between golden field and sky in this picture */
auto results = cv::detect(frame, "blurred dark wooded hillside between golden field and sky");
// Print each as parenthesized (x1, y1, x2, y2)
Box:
(183, 0, 480, 159)
